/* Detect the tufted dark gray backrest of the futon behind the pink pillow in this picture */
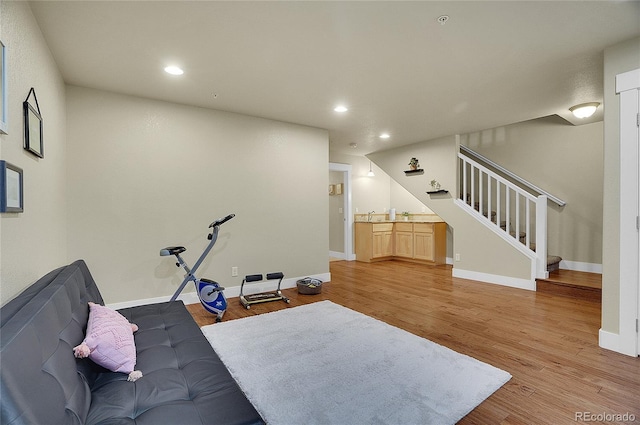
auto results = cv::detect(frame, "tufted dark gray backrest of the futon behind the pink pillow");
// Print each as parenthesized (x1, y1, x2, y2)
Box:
(0, 260, 103, 425)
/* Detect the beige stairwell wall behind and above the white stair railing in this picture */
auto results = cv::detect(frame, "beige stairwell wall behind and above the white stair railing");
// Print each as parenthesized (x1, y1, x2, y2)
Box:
(460, 116, 603, 265)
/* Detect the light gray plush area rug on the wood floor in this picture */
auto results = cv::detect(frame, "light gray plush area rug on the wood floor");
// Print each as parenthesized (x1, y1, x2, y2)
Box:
(202, 301, 511, 425)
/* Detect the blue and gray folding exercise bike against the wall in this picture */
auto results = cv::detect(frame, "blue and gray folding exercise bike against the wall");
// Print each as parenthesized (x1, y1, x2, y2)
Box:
(160, 214, 235, 322)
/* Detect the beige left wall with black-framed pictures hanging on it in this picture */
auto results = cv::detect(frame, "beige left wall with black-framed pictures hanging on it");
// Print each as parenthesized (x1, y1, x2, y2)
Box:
(0, 1, 68, 304)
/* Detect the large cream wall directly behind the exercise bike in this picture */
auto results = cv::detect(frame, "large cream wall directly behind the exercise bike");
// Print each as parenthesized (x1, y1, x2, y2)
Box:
(67, 86, 329, 303)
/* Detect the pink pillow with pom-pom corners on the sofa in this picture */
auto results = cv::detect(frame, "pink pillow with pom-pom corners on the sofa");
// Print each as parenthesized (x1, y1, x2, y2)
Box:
(73, 302, 142, 381)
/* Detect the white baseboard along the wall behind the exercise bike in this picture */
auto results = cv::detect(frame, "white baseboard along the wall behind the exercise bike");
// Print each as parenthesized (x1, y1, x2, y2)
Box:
(107, 273, 331, 310)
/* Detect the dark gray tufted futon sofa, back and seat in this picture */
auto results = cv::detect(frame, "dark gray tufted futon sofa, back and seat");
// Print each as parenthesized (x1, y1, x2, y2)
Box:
(0, 260, 264, 425)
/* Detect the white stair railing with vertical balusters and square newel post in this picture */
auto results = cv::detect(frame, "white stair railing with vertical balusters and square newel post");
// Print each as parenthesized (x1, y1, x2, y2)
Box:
(458, 153, 548, 278)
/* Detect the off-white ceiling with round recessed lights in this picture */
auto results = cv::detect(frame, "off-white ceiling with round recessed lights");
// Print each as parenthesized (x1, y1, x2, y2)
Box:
(31, 1, 640, 155)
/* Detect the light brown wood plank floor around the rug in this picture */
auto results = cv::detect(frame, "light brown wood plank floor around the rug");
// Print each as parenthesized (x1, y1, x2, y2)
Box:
(189, 261, 640, 425)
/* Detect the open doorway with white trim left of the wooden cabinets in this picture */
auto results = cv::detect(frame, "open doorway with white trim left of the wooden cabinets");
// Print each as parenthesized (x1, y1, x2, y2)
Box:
(329, 162, 355, 261)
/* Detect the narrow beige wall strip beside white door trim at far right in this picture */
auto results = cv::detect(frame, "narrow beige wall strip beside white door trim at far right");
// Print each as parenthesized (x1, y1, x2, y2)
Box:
(602, 38, 640, 333)
